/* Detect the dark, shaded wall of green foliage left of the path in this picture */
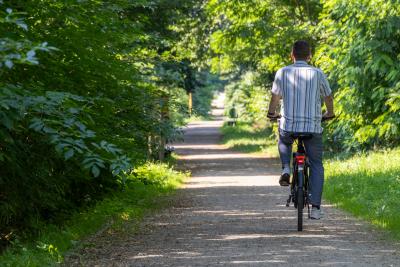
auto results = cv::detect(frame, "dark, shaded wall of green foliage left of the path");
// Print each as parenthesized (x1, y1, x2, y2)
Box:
(0, 0, 212, 247)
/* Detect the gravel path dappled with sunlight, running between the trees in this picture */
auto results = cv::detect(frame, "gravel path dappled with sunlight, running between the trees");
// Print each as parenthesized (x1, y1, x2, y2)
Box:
(67, 105, 400, 266)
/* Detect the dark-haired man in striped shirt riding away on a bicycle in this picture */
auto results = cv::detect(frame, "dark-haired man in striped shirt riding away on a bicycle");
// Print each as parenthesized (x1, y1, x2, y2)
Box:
(268, 41, 335, 219)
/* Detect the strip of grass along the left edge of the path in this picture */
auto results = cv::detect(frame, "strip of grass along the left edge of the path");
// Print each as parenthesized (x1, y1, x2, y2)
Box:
(0, 163, 186, 266)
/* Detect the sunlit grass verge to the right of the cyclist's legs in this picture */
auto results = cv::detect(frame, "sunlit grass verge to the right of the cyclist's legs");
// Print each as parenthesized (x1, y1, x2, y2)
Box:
(324, 149, 400, 238)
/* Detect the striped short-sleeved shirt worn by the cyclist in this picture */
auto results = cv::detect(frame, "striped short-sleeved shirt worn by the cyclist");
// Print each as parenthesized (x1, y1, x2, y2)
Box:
(272, 60, 332, 133)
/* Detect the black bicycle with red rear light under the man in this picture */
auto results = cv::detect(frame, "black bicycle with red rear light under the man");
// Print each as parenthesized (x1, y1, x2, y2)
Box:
(270, 115, 334, 231)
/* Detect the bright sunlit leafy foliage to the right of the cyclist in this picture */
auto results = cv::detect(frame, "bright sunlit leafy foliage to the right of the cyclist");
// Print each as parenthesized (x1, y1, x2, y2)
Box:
(316, 0, 400, 149)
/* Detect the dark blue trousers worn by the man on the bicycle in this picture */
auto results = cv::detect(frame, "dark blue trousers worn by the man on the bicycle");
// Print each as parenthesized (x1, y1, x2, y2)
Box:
(278, 130, 324, 205)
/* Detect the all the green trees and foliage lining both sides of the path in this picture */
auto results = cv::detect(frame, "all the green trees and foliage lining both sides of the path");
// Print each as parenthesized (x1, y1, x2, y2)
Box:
(0, 0, 400, 264)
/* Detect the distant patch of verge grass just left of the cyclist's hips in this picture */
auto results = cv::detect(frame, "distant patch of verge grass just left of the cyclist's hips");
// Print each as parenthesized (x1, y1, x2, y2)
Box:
(221, 122, 278, 156)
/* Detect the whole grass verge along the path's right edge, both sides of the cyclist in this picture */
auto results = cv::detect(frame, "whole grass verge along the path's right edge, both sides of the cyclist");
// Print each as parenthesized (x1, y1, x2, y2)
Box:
(222, 123, 400, 239)
